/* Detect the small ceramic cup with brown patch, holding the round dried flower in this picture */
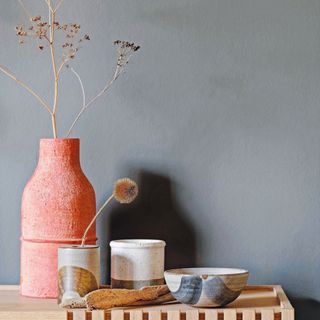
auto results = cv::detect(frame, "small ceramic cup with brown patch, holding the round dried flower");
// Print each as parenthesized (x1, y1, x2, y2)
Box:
(58, 245, 100, 306)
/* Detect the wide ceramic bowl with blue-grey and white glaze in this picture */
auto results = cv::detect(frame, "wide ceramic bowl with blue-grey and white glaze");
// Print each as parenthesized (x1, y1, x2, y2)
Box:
(164, 268, 249, 307)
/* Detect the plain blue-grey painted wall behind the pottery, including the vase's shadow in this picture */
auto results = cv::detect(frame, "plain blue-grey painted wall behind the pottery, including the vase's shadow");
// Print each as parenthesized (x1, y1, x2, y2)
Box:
(0, 0, 320, 319)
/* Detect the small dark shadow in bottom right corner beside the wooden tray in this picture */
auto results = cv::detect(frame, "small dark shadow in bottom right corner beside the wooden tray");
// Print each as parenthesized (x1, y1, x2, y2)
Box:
(290, 298, 320, 320)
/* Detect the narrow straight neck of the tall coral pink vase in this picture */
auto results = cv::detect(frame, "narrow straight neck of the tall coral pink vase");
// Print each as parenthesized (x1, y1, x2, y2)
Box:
(39, 139, 80, 166)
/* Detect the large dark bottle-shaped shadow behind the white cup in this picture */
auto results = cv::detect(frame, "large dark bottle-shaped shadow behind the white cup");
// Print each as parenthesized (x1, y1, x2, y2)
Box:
(107, 171, 196, 280)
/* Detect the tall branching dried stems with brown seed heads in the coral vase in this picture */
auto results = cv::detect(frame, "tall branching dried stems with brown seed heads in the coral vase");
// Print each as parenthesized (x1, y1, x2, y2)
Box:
(0, 0, 140, 138)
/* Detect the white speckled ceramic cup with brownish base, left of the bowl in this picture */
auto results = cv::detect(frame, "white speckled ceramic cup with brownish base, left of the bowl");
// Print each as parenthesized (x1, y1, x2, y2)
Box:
(110, 239, 166, 289)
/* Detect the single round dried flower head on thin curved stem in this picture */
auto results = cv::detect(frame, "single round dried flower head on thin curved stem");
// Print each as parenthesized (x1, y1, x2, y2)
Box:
(81, 178, 138, 246)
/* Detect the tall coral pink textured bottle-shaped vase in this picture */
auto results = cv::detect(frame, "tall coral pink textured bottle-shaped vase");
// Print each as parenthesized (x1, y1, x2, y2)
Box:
(20, 139, 96, 298)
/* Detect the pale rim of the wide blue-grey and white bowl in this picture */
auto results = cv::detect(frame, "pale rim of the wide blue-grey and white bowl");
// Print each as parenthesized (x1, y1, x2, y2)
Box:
(164, 267, 249, 277)
